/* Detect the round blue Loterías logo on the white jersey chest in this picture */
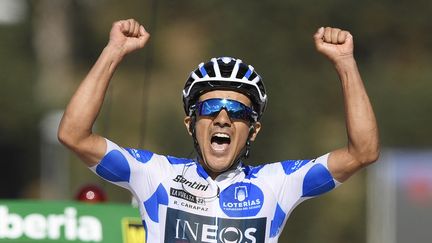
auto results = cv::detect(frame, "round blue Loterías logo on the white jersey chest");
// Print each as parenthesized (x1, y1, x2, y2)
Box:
(219, 182, 264, 217)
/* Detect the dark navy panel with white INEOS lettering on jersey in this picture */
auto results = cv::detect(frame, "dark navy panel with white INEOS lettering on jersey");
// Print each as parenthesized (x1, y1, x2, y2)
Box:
(164, 208, 266, 243)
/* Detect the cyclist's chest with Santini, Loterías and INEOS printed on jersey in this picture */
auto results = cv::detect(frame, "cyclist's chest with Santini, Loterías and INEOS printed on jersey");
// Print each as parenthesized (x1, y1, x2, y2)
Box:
(161, 175, 277, 242)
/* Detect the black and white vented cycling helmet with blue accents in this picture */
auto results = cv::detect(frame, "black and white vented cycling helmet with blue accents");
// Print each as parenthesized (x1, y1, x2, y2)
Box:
(183, 57, 267, 120)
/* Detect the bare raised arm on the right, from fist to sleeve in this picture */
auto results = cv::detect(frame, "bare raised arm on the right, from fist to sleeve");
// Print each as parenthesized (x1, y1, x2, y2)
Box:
(314, 27, 379, 182)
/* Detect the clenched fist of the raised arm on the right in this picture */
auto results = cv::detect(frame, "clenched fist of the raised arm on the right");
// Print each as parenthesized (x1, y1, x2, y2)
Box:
(314, 27, 354, 63)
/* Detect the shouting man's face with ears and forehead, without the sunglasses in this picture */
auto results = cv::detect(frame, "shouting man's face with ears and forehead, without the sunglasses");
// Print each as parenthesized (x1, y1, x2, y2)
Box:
(185, 90, 261, 178)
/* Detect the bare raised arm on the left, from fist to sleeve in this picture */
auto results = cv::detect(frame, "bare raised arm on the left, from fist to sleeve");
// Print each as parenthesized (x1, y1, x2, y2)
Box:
(58, 19, 150, 166)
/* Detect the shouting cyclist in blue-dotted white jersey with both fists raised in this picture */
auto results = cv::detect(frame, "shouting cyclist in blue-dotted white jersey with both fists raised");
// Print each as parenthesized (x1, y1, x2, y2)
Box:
(58, 19, 379, 242)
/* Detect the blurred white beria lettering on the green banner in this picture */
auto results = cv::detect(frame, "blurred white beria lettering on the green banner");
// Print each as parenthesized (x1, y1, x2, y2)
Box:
(0, 206, 102, 242)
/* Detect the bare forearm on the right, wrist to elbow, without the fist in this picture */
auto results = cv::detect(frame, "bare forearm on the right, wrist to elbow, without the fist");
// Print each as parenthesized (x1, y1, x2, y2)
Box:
(335, 57, 379, 165)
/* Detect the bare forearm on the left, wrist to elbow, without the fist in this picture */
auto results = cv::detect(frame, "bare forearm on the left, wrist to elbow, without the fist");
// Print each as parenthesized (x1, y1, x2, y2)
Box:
(59, 46, 122, 147)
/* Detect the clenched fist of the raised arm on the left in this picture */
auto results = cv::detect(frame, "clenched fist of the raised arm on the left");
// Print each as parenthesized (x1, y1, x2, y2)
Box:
(108, 19, 150, 55)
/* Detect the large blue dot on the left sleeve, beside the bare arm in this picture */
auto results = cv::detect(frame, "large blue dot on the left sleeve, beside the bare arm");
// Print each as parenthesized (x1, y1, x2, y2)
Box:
(96, 150, 130, 182)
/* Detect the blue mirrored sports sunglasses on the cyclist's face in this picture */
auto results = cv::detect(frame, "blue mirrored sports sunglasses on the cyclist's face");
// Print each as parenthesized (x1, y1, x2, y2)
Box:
(196, 98, 258, 122)
